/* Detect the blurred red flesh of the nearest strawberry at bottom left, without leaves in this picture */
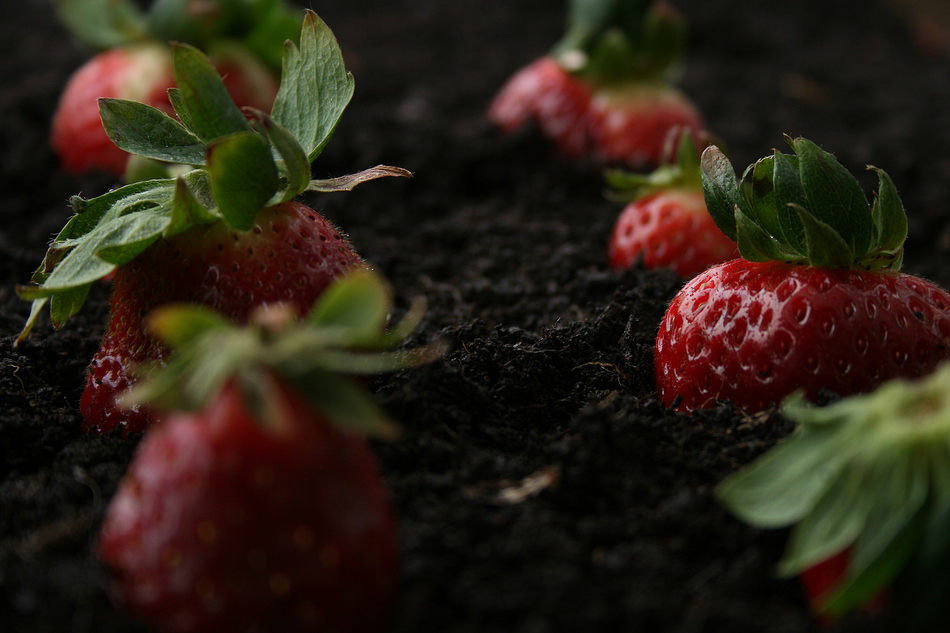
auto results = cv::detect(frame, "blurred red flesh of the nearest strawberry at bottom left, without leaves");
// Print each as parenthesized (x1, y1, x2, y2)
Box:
(98, 383, 399, 633)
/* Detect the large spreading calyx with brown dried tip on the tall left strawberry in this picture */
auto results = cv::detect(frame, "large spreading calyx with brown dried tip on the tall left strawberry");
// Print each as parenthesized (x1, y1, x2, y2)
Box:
(17, 11, 411, 342)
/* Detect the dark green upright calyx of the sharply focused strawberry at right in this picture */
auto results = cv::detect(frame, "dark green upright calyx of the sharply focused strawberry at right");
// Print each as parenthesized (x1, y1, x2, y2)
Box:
(700, 137, 907, 270)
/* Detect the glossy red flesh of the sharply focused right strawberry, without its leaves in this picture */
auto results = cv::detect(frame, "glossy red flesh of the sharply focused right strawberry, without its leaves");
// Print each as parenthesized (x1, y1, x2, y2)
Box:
(655, 259, 950, 411)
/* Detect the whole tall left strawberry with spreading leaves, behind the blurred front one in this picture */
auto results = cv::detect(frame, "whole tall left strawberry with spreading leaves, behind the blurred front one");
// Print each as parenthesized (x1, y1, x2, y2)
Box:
(18, 12, 409, 432)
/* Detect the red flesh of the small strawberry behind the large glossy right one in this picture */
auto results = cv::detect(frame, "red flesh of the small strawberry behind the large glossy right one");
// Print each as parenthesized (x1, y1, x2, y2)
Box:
(608, 189, 739, 277)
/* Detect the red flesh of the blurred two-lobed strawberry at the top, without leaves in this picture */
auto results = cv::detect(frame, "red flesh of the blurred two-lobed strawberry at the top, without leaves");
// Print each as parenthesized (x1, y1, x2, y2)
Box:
(488, 56, 706, 168)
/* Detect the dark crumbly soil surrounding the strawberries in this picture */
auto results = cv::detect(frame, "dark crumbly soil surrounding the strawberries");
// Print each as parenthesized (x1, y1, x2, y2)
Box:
(0, 0, 950, 633)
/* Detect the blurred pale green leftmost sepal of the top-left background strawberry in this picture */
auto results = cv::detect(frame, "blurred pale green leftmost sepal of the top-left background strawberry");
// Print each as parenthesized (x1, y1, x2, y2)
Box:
(55, 0, 149, 50)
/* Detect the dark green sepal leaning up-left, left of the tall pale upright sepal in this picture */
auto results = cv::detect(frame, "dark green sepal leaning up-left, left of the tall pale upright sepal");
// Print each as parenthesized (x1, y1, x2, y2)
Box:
(169, 44, 251, 144)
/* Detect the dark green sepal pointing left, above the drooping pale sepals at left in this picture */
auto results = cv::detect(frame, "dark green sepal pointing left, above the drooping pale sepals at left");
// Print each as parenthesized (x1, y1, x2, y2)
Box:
(99, 99, 207, 165)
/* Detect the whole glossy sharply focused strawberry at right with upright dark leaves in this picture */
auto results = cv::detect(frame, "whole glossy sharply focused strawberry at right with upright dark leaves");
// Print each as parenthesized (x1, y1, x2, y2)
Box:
(655, 139, 950, 411)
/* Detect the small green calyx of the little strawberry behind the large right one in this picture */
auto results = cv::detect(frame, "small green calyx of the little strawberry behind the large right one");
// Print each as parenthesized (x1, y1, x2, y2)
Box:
(604, 128, 703, 202)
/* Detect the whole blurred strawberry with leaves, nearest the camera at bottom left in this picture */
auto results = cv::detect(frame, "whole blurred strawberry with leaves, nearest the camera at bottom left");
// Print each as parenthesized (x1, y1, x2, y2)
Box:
(98, 271, 442, 633)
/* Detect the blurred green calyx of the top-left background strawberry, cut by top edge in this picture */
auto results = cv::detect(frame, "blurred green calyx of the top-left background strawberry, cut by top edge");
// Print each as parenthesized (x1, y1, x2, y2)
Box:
(56, 0, 300, 70)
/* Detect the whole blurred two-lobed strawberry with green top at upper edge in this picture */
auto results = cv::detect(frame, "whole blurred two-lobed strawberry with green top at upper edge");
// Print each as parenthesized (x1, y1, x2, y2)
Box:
(488, 0, 706, 169)
